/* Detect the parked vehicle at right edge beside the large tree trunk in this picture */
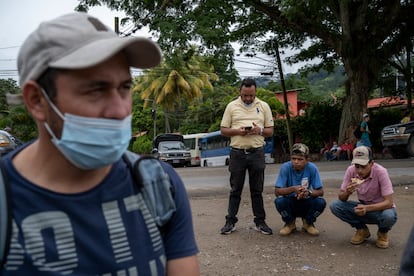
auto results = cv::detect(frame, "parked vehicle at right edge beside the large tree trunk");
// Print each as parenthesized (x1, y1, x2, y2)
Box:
(381, 121, 414, 158)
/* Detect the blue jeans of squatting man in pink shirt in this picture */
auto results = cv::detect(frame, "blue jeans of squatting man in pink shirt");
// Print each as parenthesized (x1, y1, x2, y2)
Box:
(330, 200, 397, 233)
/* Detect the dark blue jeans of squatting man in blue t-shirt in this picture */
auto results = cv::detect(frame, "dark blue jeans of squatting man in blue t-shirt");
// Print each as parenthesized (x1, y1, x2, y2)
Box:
(275, 196, 326, 224)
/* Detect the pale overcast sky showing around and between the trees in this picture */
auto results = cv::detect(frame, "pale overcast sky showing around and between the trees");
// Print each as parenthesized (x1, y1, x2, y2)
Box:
(0, 0, 304, 84)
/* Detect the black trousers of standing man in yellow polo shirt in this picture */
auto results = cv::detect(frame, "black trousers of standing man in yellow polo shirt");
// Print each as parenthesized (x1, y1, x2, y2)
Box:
(226, 149, 266, 224)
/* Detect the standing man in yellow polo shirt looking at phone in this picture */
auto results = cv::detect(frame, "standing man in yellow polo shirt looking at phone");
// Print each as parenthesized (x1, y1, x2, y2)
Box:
(221, 78, 273, 235)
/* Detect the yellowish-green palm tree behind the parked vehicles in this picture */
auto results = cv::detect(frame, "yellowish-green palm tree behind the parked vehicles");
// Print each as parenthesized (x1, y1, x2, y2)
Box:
(133, 46, 218, 133)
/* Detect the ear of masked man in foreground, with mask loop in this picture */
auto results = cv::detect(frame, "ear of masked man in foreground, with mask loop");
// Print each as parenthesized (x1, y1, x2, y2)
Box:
(23, 81, 49, 121)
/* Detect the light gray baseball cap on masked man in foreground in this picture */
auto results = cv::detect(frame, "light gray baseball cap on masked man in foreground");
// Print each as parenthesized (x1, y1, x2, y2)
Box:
(17, 12, 161, 87)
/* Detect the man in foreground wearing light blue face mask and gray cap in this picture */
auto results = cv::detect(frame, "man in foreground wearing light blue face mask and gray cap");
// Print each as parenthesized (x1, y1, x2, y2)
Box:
(0, 13, 199, 276)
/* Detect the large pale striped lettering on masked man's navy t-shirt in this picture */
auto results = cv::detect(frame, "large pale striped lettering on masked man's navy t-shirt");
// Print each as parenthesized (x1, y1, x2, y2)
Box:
(5, 193, 166, 276)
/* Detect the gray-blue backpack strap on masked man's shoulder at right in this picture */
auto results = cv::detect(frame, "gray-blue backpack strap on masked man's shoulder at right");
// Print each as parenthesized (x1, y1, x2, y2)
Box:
(123, 151, 176, 229)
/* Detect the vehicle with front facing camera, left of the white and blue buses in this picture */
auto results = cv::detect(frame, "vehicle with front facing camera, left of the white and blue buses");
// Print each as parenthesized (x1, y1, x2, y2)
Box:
(152, 133, 191, 167)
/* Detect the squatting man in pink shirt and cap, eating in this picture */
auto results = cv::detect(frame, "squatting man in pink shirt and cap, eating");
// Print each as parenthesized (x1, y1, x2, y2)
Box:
(330, 146, 397, 248)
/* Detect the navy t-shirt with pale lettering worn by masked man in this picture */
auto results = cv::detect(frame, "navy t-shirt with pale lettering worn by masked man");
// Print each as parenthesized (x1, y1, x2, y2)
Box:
(0, 146, 198, 275)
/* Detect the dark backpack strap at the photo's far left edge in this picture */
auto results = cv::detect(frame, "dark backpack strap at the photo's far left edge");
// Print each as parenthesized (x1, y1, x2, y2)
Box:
(0, 160, 12, 269)
